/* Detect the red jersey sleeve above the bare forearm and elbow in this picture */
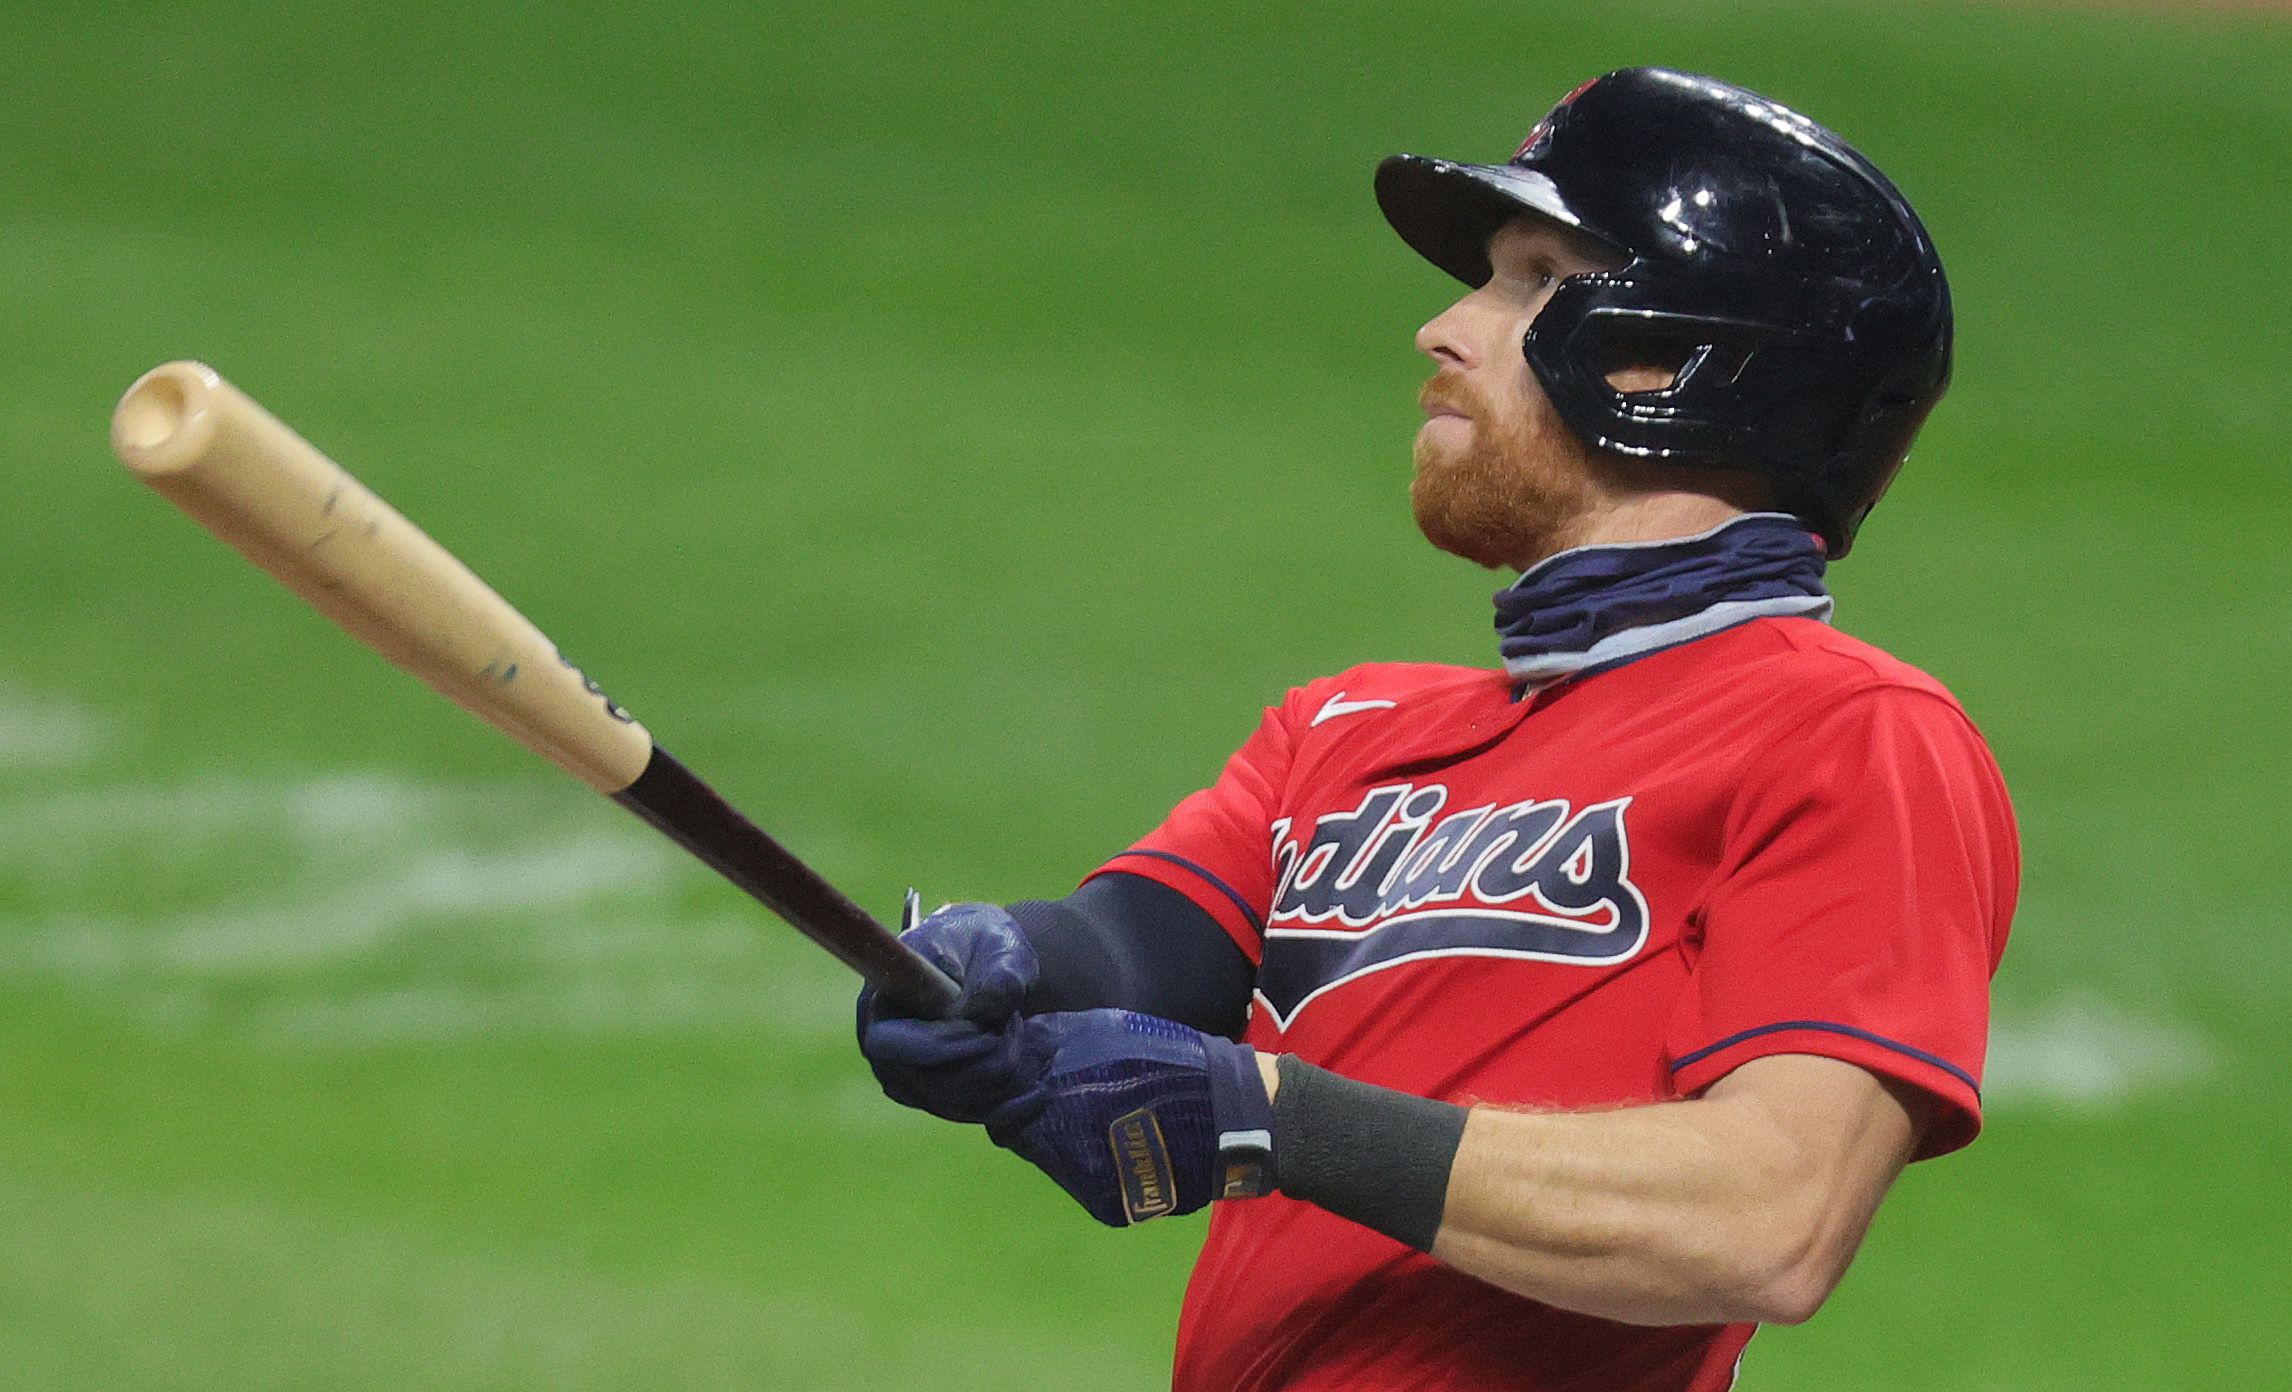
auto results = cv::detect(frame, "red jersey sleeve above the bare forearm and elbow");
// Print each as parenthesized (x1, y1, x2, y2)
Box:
(1666, 686, 2019, 1158)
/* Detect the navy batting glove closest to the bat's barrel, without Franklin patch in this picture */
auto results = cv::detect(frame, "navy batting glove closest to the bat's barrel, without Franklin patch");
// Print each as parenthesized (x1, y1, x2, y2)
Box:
(860, 904, 1041, 1121)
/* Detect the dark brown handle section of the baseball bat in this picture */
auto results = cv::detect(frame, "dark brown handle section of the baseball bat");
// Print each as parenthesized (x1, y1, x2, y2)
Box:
(612, 745, 963, 1018)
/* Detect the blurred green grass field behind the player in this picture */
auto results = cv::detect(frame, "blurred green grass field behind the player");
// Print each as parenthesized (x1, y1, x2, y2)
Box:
(0, 0, 2292, 1392)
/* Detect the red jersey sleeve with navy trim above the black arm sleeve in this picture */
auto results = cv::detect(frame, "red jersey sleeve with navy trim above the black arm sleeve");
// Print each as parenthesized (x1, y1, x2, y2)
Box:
(1093, 688, 1302, 965)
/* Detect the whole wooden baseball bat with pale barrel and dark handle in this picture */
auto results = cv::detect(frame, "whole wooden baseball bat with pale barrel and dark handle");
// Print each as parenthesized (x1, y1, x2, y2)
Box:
(112, 362, 956, 1014)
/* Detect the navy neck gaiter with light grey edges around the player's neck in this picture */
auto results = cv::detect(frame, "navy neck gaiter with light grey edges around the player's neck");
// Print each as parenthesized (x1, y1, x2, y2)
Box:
(1494, 511, 1831, 690)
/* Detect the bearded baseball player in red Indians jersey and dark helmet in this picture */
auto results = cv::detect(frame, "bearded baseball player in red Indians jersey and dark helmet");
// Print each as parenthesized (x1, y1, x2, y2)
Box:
(860, 69, 2019, 1392)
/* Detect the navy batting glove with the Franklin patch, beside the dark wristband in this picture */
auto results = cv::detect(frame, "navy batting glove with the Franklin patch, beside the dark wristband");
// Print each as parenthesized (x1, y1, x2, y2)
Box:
(986, 1009, 1274, 1227)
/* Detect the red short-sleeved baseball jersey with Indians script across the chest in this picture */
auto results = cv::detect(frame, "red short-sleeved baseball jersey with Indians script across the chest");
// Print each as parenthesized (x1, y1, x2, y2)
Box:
(1105, 619, 2019, 1392)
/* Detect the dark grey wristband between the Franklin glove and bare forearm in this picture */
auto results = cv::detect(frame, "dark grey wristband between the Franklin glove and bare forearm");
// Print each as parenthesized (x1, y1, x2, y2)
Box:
(1274, 1055, 1467, 1252)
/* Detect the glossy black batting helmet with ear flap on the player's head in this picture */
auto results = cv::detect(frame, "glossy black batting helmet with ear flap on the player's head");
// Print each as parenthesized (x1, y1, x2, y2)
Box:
(1377, 69, 1950, 555)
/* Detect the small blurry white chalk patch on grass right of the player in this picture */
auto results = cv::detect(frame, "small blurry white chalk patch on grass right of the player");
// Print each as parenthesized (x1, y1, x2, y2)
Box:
(1983, 993, 2219, 1110)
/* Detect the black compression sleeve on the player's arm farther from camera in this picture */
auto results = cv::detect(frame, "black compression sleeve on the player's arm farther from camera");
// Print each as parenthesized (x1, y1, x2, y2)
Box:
(1011, 871, 1258, 1039)
